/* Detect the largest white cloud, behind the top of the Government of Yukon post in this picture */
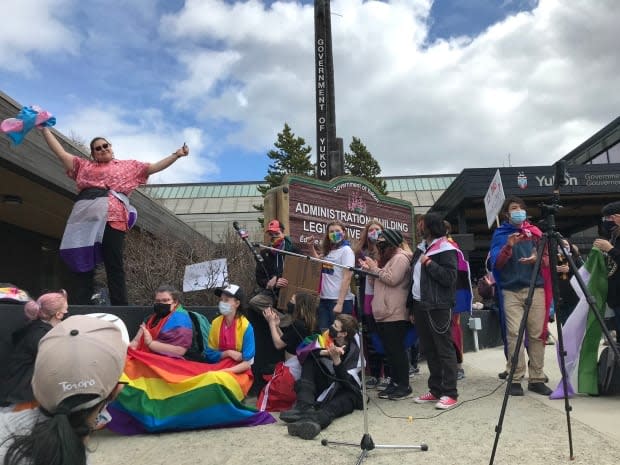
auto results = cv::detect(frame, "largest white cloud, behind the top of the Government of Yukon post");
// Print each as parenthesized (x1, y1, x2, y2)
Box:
(160, 0, 620, 175)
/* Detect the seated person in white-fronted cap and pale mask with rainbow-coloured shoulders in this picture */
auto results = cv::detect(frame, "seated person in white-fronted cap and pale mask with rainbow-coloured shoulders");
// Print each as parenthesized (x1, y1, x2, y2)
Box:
(205, 284, 256, 373)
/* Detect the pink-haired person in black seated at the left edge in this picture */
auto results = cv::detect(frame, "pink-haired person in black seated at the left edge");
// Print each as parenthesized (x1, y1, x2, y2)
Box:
(0, 289, 68, 411)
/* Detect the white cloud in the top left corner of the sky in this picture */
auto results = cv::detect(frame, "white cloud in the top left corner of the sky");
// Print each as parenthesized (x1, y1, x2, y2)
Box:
(0, 0, 79, 74)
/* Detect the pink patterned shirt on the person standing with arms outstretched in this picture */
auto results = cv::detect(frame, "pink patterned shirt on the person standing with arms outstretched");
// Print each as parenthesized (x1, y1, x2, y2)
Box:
(67, 157, 150, 231)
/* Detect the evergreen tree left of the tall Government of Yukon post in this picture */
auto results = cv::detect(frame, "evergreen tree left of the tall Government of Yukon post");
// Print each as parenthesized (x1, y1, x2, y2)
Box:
(254, 123, 314, 218)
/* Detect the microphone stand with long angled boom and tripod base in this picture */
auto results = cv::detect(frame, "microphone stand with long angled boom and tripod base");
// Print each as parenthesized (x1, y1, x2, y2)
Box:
(254, 244, 428, 465)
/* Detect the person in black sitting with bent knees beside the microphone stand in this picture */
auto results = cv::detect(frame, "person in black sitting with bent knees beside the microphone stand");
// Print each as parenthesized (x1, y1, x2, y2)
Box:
(280, 314, 362, 439)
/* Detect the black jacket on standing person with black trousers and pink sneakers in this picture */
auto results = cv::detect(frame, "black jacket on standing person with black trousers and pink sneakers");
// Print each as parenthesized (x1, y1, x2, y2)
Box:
(411, 248, 458, 309)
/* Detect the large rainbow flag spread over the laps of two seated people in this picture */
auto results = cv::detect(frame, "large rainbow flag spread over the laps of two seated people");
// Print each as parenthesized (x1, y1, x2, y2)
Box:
(108, 349, 276, 435)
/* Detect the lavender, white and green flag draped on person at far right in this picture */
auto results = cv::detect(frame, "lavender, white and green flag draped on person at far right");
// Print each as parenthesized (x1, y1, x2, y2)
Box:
(549, 249, 607, 399)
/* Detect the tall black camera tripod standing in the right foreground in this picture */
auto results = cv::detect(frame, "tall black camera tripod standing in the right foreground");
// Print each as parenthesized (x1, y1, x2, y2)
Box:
(489, 170, 620, 465)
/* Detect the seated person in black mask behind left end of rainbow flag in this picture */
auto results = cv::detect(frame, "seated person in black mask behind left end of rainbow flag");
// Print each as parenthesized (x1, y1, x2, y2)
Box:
(129, 284, 192, 357)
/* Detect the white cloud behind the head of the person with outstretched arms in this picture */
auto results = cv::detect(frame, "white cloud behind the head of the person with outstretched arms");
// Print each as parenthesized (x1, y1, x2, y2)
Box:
(58, 106, 218, 183)
